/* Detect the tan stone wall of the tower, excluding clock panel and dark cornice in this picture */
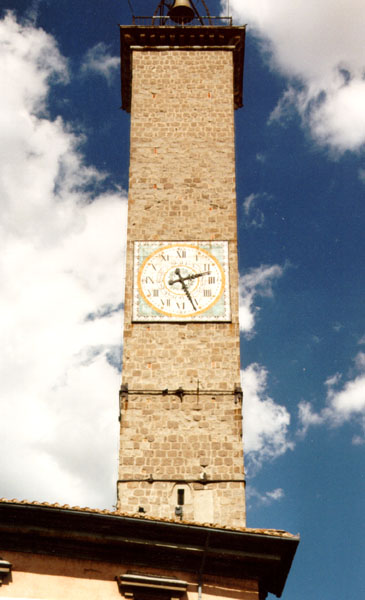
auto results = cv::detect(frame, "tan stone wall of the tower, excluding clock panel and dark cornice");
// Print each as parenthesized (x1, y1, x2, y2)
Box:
(118, 48, 245, 526)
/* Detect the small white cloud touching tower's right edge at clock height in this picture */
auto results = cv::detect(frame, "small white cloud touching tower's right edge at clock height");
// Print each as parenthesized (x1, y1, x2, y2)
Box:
(239, 265, 284, 337)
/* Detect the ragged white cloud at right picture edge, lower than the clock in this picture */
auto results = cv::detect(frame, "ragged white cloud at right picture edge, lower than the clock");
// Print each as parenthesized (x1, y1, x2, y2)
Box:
(299, 352, 365, 444)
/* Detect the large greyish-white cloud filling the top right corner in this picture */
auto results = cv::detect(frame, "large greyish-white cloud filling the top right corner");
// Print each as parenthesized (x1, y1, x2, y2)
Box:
(226, 0, 365, 152)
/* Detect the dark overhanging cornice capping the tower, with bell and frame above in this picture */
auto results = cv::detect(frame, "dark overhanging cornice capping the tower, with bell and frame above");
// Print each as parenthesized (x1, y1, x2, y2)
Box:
(120, 0, 246, 112)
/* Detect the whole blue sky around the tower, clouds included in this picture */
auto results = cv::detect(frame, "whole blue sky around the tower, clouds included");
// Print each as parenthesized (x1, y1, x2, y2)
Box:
(0, 0, 365, 600)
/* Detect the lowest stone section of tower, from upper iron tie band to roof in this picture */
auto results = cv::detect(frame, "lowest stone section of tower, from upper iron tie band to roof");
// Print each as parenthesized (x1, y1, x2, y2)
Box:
(118, 393, 244, 526)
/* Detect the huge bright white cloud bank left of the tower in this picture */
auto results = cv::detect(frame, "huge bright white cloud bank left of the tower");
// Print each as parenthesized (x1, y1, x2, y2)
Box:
(0, 14, 126, 507)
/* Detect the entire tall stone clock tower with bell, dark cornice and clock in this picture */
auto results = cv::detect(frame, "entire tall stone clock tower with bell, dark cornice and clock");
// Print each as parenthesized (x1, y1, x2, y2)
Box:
(118, 0, 245, 527)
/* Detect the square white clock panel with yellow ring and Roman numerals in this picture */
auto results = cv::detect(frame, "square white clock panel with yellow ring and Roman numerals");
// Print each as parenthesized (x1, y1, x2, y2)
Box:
(133, 242, 230, 322)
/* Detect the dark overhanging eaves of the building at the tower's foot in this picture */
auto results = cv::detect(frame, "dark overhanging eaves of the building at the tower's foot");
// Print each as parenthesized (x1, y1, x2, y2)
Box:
(0, 501, 299, 596)
